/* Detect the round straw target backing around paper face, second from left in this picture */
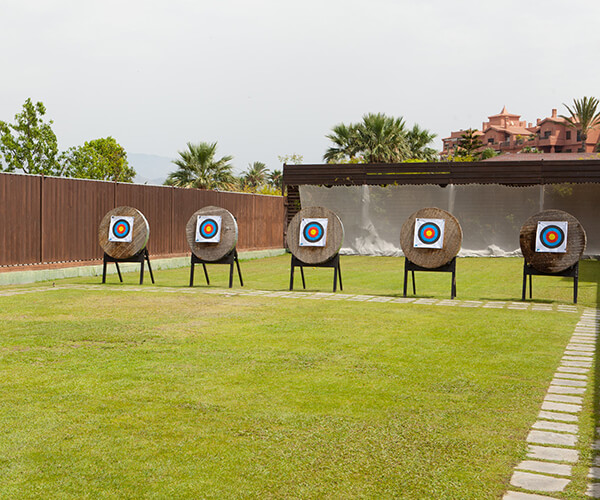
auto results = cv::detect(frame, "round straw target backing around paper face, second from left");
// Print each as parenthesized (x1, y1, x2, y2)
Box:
(185, 206, 238, 262)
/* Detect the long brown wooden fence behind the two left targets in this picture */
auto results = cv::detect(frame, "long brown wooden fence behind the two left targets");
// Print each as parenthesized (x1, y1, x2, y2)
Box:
(0, 173, 284, 266)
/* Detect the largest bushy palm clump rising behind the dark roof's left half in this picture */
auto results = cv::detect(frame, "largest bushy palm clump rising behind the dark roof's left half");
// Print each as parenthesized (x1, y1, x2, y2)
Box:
(323, 113, 409, 163)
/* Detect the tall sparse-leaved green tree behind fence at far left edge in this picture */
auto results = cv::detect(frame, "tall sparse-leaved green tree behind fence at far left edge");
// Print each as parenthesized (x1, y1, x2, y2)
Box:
(0, 98, 62, 175)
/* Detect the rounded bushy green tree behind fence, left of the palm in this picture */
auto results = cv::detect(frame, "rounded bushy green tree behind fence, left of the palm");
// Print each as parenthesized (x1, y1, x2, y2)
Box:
(60, 137, 135, 182)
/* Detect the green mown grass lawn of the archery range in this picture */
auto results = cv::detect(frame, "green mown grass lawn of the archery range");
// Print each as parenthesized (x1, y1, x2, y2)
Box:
(0, 257, 600, 499)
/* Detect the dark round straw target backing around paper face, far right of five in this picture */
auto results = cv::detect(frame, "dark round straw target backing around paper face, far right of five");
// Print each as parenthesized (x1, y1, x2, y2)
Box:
(519, 210, 586, 273)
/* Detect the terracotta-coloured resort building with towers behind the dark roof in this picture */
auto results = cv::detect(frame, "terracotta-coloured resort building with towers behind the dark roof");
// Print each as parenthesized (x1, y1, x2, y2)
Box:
(441, 106, 600, 156)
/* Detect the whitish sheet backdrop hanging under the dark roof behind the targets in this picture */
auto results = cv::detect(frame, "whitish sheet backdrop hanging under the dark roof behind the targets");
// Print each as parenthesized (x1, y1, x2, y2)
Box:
(300, 184, 600, 257)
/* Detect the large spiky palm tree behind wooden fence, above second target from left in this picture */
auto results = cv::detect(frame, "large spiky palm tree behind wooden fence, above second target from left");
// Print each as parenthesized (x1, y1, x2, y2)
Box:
(165, 142, 234, 189)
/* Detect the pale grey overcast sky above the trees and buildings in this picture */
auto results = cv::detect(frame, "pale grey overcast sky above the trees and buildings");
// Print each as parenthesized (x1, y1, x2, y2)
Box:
(0, 0, 600, 174)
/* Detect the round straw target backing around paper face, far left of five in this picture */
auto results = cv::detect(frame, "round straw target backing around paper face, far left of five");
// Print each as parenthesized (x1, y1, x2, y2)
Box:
(98, 207, 150, 259)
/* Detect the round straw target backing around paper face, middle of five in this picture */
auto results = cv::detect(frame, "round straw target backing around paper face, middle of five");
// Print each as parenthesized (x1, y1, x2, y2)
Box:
(286, 207, 344, 264)
